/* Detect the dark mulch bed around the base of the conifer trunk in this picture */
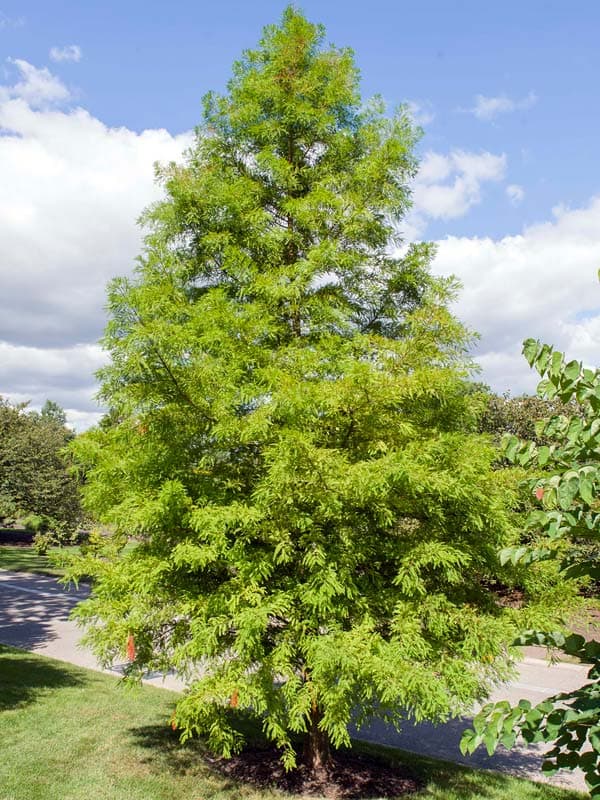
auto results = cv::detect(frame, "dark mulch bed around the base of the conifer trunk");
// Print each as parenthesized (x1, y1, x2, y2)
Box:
(215, 748, 422, 800)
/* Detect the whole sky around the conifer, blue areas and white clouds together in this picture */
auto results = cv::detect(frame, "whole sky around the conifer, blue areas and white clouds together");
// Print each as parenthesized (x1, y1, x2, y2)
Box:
(0, 0, 600, 424)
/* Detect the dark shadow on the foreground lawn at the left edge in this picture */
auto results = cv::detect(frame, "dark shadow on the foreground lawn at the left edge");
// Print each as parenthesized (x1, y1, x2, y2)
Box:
(0, 645, 85, 711)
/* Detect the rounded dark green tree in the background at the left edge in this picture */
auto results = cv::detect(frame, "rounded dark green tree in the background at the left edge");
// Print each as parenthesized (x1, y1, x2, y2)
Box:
(0, 398, 81, 537)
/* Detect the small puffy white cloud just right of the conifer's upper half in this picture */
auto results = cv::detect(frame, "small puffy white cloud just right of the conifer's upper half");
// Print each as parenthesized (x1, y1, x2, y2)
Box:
(413, 150, 506, 220)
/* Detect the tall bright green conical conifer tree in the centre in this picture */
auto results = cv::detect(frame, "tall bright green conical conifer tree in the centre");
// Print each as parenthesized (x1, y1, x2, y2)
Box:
(73, 9, 544, 767)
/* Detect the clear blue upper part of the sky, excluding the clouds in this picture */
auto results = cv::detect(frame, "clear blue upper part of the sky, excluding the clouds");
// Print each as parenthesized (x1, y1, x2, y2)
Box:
(5, 0, 600, 237)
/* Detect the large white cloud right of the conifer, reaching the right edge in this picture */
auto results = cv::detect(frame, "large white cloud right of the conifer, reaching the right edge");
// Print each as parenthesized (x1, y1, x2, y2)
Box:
(434, 197, 600, 392)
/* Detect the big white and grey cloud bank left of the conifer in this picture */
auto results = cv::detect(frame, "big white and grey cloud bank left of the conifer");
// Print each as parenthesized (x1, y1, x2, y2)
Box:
(0, 60, 191, 432)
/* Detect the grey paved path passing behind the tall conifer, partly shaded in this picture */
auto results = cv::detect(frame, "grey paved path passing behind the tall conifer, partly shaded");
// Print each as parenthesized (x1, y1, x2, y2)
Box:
(0, 570, 588, 789)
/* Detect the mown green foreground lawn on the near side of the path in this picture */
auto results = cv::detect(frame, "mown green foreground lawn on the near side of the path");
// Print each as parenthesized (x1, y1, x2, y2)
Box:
(0, 646, 583, 800)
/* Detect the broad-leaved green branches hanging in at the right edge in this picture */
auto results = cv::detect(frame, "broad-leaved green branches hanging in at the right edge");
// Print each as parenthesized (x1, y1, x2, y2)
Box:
(462, 339, 600, 797)
